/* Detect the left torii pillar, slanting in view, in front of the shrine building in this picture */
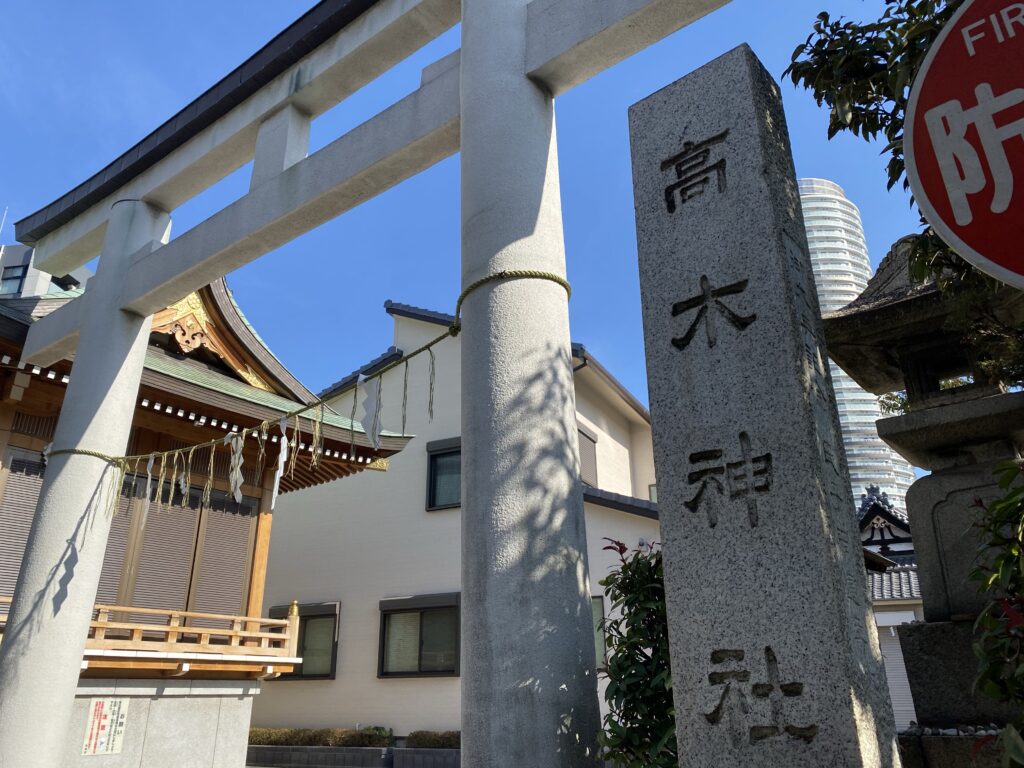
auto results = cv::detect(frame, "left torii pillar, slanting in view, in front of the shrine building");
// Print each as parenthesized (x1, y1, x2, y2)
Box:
(0, 200, 171, 768)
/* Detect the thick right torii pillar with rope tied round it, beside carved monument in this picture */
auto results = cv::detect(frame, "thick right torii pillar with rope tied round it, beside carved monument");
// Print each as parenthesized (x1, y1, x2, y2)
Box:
(461, 0, 599, 768)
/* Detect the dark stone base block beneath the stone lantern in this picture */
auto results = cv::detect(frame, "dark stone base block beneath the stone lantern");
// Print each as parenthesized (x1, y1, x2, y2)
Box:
(896, 622, 1017, 728)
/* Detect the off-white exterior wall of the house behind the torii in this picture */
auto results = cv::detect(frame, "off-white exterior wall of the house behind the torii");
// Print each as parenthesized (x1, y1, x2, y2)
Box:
(253, 317, 658, 735)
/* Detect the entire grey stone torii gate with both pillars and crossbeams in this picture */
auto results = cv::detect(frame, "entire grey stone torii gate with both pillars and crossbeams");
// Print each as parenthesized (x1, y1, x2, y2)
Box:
(0, 0, 727, 768)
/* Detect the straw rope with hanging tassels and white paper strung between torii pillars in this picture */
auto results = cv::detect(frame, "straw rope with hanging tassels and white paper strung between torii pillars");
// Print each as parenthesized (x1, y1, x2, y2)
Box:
(39, 269, 572, 524)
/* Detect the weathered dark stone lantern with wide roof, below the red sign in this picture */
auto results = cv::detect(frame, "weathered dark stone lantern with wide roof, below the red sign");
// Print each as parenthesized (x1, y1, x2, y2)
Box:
(824, 241, 1024, 764)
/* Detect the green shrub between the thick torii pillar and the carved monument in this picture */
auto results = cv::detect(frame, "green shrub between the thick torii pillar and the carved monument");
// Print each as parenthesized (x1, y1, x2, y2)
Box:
(600, 539, 679, 768)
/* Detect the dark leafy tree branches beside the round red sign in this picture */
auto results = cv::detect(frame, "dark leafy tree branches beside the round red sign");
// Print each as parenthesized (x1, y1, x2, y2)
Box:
(785, 0, 1024, 384)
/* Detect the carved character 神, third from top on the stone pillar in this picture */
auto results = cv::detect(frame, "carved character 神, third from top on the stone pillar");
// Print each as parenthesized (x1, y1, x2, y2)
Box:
(685, 432, 772, 528)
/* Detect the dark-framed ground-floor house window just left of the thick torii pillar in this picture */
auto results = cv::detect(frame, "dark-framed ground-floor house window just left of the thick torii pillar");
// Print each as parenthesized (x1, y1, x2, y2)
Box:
(377, 593, 459, 677)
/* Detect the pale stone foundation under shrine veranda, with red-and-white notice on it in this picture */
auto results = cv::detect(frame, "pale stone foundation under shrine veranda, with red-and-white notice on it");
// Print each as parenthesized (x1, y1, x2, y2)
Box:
(62, 680, 259, 768)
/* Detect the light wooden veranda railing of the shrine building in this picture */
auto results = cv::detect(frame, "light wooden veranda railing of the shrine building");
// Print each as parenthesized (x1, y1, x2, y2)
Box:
(0, 597, 302, 680)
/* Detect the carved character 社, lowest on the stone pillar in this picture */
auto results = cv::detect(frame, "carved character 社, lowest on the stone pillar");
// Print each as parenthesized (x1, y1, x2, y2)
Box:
(705, 646, 818, 746)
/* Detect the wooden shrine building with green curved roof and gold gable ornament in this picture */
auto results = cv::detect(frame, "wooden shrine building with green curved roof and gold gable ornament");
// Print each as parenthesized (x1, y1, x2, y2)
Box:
(0, 246, 408, 765)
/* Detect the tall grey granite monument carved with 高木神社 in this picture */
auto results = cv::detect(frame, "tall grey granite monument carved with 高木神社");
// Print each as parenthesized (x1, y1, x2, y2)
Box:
(630, 46, 900, 768)
